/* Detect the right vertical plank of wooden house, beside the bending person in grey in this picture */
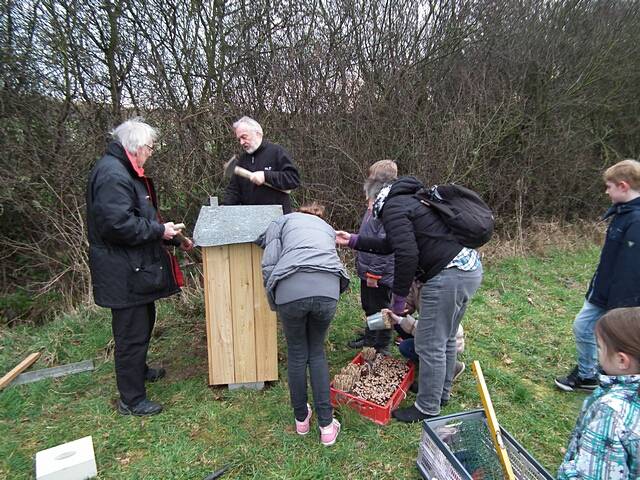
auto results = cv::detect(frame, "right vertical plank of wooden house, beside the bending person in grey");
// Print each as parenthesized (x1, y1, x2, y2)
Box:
(251, 244, 278, 381)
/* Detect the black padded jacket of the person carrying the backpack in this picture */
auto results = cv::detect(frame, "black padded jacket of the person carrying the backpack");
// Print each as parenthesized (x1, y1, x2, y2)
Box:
(355, 177, 463, 297)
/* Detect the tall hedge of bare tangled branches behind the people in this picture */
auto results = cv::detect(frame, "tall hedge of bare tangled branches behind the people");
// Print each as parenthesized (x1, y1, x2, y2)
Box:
(6, 0, 640, 303)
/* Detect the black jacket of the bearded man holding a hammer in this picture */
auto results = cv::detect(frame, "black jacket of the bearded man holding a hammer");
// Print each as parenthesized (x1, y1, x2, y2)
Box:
(221, 140, 300, 214)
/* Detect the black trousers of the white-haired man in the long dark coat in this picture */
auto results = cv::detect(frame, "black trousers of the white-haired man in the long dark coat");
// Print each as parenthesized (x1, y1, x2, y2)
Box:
(111, 302, 156, 406)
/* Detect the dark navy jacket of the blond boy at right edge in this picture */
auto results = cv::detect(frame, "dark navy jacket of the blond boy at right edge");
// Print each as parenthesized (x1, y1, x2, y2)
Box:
(586, 198, 640, 310)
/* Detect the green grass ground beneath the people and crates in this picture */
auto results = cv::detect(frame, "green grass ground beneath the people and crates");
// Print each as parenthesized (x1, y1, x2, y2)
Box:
(0, 247, 598, 479)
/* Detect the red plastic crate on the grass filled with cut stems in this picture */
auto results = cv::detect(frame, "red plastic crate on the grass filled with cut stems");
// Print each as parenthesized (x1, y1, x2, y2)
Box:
(331, 353, 415, 425)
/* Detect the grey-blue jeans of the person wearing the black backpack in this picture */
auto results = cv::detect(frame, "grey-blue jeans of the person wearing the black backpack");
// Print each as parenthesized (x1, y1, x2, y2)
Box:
(415, 267, 482, 415)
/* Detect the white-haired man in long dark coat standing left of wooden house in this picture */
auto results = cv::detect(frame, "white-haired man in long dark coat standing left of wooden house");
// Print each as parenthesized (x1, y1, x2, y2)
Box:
(86, 118, 193, 416)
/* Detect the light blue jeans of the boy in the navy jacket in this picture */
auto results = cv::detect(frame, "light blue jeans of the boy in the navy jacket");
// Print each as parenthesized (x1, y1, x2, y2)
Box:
(573, 300, 607, 378)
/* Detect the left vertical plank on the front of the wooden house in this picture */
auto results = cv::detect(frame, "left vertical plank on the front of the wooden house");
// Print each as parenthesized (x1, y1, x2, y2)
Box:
(202, 245, 236, 385)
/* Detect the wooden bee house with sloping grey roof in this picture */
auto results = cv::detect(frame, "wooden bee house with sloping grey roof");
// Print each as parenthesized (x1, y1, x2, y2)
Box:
(194, 200, 282, 385)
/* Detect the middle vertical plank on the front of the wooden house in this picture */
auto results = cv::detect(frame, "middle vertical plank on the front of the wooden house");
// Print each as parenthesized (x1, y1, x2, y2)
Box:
(229, 243, 258, 383)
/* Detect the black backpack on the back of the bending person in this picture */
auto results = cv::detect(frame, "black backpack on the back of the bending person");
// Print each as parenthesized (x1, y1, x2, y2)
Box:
(414, 184, 495, 248)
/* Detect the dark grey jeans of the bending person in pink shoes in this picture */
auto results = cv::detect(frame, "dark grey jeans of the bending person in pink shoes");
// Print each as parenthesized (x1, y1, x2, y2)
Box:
(276, 297, 338, 427)
